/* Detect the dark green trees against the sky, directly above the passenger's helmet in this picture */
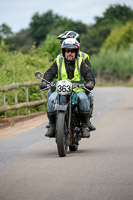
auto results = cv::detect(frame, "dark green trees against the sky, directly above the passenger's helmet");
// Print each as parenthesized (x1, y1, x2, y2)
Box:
(30, 10, 88, 46)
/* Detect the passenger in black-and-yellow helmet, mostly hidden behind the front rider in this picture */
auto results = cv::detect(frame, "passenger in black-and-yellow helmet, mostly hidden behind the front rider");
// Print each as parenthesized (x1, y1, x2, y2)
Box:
(57, 31, 96, 131)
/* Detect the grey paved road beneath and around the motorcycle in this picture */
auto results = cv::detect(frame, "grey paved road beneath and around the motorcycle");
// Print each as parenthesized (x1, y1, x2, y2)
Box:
(0, 87, 133, 200)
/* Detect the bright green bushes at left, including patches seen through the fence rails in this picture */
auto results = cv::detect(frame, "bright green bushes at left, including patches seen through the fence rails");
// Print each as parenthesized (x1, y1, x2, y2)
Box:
(0, 40, 51, 116)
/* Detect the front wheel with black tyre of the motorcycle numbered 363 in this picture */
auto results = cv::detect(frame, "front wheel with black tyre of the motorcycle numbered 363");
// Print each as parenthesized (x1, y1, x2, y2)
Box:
(56, 112, 68, 157)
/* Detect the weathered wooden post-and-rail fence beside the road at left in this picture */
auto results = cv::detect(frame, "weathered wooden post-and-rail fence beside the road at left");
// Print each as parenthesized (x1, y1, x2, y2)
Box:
(0, 81, 47, 113)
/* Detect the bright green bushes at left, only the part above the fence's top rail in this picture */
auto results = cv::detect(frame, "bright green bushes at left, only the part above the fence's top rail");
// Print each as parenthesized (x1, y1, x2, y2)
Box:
(0, 42, 51, 85)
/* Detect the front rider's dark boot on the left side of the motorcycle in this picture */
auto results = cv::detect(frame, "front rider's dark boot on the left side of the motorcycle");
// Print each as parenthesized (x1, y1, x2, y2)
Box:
(45, 112, 55, 137)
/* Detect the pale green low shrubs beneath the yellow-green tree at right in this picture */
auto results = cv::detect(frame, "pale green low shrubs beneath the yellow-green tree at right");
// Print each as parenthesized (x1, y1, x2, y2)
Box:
(91, 45, 133, 75)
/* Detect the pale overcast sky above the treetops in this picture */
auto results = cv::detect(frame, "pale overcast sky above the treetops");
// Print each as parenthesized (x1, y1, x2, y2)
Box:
(0, 0, 133, 32)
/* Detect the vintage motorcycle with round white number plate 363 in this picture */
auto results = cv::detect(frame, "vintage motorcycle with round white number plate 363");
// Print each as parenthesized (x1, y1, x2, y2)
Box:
(35, 71, 90, 157)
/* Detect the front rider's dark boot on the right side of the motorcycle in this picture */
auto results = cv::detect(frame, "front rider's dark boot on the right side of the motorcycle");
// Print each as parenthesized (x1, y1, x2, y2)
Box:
(80, 111, 90, 138)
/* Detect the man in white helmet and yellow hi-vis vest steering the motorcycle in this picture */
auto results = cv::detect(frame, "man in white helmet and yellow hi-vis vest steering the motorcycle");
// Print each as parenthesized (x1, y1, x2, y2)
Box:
(40, 38, 95, 138)
